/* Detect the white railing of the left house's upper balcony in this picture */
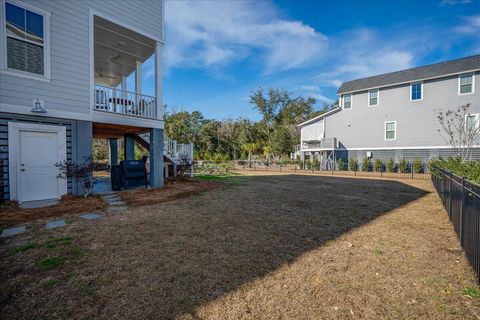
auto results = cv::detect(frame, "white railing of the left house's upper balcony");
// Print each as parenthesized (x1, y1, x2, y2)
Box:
(93, 84, 157, 119)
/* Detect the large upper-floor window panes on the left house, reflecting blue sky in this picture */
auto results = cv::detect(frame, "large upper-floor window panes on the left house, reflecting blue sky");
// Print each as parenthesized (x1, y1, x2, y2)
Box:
(5, 2, 46, 76)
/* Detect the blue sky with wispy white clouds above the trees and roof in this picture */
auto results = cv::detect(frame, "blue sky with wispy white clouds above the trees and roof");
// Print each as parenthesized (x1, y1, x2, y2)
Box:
(155, 0, 480, 120)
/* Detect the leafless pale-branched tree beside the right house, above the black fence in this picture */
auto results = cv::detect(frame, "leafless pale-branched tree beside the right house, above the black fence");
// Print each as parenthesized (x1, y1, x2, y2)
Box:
(437, 103, 480, 161)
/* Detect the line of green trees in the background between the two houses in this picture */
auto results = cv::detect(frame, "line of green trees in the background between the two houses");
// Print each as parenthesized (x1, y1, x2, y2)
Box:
(165, 88, 334, 161)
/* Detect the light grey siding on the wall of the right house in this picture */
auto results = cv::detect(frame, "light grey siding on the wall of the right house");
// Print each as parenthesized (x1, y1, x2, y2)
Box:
(325, 72, 480, 150)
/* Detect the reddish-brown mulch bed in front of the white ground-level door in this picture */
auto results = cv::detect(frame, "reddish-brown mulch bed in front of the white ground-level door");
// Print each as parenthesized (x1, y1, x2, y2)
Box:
(0, 195, 107, 226)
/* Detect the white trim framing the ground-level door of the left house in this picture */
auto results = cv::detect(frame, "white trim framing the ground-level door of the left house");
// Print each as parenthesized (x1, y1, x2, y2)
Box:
(8, 121, 67, 200)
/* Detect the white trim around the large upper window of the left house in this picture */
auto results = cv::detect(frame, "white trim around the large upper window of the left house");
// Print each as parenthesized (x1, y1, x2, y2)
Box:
(0, 0, 51, 82)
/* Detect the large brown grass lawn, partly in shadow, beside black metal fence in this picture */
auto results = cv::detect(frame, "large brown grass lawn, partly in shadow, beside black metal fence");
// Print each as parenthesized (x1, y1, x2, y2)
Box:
(0, 174, 480, 319)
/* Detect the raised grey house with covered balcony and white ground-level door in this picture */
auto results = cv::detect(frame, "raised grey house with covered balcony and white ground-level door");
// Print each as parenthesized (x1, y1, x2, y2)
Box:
(0, 0, 191, 203)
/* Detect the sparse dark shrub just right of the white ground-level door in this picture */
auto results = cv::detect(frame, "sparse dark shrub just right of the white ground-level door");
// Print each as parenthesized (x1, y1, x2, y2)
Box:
(55, 157, 95, 198)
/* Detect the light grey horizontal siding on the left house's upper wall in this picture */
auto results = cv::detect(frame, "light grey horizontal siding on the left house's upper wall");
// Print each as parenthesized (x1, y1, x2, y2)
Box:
(0, 0, 163, 119)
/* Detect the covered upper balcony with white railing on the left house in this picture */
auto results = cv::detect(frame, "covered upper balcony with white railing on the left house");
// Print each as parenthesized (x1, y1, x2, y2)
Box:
(91, 16, 162, 119)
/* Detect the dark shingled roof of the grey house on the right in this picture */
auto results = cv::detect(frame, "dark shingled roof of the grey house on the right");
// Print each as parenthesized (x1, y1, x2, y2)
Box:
(337, 55, 480, 94)
